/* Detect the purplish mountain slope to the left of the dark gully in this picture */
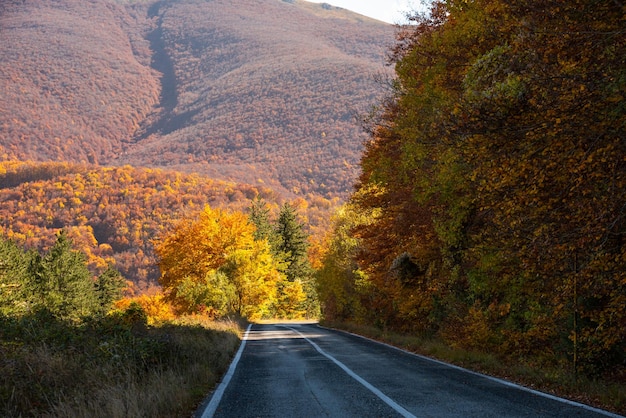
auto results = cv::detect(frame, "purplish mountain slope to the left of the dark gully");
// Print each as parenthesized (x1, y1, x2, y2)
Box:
(0, 0, 160, 163)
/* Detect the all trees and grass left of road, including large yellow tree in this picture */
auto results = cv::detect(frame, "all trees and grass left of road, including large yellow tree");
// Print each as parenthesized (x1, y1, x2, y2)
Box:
(0, 200, 319, 417)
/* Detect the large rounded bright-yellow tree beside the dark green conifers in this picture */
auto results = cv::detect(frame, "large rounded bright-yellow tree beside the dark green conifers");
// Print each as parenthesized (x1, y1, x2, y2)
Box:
(155, 206, 279, 317)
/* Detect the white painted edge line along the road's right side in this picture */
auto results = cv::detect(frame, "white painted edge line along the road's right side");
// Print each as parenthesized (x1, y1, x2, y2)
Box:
(317, 324, 626, 418)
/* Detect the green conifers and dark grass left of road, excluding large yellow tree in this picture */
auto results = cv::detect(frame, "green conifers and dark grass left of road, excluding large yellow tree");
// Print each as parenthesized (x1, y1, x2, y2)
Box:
(0, 232, 241, 417)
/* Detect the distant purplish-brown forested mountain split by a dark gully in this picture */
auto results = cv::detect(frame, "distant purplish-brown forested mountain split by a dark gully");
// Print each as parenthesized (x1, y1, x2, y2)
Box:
(0, 0, 394, 197)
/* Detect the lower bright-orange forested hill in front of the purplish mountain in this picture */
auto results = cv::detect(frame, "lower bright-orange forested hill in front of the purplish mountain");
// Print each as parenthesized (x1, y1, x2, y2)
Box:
(0, 162, 337, 289)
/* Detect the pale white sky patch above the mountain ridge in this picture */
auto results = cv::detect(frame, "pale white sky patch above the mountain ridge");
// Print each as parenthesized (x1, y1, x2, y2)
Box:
(308, 0, 421, 23)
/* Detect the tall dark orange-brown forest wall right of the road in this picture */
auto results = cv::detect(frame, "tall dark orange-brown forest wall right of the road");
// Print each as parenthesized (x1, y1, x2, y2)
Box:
(318, 0, 626, 390)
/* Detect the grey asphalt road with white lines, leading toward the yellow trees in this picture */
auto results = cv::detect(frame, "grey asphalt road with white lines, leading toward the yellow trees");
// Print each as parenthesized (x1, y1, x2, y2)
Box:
(197, 324, 617, 418)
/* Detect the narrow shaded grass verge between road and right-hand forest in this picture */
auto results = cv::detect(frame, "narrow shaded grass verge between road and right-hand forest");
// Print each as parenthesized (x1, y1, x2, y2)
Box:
(321, 321, 626, 415)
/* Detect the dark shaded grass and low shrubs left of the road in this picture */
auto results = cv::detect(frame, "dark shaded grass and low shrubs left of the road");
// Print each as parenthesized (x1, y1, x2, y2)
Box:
(0, 314, 242, 418)
